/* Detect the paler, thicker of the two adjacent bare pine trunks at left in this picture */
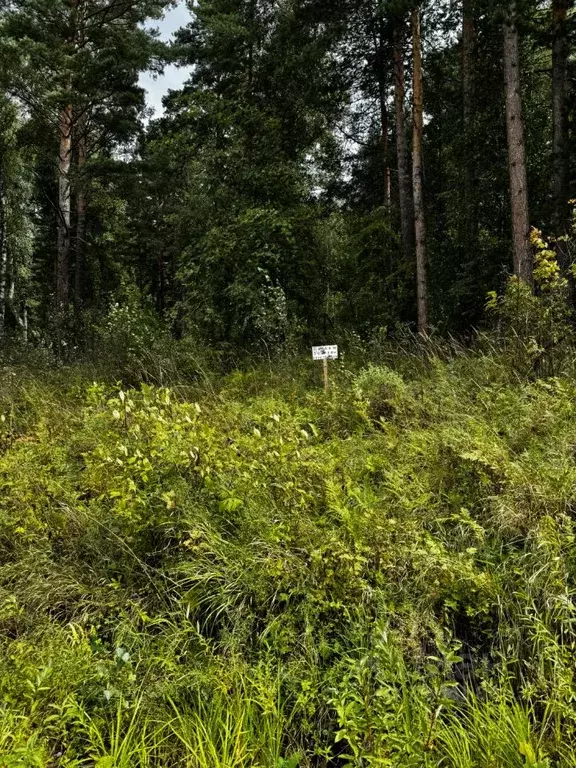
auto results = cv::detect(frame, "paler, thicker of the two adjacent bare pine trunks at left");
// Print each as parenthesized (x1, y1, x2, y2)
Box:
(56, 104, 72, 317)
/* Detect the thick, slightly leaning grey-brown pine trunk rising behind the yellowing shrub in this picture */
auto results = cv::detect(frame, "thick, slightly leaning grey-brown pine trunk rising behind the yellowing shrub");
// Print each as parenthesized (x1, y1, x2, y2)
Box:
(504, 2, 532, 284)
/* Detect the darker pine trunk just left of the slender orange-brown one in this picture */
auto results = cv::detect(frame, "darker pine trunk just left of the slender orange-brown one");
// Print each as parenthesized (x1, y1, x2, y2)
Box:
(394, 24, 415, 263)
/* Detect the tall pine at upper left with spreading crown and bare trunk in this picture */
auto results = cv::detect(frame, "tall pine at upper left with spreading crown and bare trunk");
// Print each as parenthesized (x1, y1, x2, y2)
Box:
(1, 0, 169, 324)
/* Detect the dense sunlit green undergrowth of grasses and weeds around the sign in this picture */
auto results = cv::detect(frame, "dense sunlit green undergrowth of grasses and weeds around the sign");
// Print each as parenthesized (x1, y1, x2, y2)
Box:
(0, 344, 576, 768)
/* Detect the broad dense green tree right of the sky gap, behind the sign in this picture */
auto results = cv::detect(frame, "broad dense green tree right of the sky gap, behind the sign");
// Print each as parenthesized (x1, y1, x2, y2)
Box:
(157, 0, 340, 340)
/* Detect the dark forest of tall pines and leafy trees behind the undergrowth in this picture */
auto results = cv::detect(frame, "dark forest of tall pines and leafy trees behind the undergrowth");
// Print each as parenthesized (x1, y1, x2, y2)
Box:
(0, 0, 576, 355)
